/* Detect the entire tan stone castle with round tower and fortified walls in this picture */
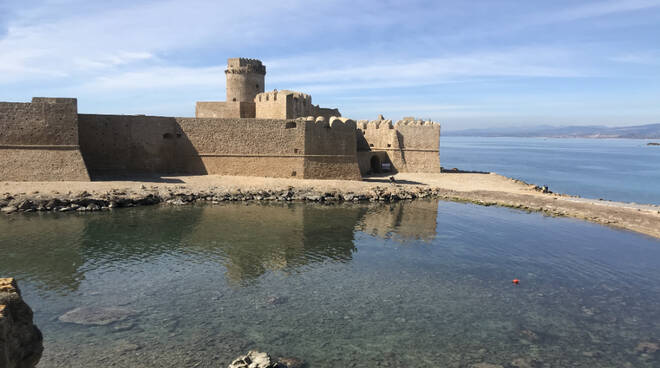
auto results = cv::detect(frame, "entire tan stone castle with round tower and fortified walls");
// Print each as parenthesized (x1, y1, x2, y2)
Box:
(0, 58, 440, 181)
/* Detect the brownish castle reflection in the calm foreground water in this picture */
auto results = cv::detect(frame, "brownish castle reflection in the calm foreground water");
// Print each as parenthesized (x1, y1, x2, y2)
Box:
(0, 201, 438, 293)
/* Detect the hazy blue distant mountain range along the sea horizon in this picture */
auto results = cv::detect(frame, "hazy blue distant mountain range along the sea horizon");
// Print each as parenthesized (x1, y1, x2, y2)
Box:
(442, 124, 660, 139)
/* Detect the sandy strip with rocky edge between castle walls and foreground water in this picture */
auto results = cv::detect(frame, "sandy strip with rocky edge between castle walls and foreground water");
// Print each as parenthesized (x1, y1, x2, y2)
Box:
(0, 172, 660, 242)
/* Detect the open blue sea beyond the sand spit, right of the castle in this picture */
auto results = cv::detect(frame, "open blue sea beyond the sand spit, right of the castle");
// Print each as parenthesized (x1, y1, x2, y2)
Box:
(440, 137, 660, 204)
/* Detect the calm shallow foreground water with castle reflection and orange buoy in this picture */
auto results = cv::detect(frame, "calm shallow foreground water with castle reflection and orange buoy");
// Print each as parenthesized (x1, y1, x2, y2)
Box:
(0, 201, 660, 367)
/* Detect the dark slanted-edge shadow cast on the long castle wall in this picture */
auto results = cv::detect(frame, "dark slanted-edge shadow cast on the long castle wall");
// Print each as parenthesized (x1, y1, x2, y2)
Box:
(78, 114, 207, 182)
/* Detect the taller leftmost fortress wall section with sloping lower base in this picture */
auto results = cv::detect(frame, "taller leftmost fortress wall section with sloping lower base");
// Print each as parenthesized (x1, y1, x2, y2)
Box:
(0, 97, 89, 181)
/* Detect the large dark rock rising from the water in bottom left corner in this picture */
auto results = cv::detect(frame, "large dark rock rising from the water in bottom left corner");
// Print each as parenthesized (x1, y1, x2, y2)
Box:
(0, 278, 44, 368)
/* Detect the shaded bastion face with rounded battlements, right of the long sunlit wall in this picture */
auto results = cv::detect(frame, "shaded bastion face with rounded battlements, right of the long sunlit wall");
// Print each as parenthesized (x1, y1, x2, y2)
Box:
(300, 118, 362, 180)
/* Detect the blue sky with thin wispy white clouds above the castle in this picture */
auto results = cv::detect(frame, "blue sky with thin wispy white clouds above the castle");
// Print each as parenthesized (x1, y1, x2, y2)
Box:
(0, 0, 660, 130)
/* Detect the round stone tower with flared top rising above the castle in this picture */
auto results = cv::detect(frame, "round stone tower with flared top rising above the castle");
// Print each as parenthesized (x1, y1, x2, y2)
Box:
(225, 58, 266, 102)
